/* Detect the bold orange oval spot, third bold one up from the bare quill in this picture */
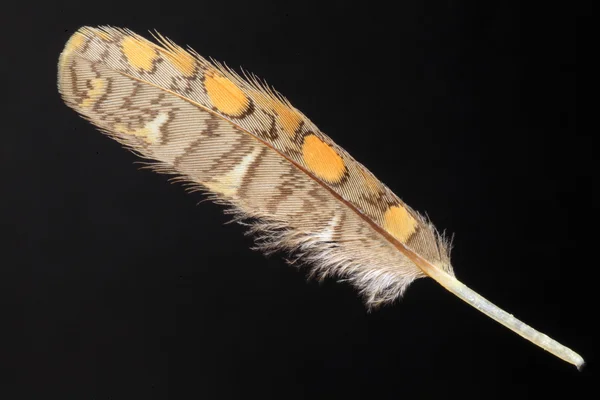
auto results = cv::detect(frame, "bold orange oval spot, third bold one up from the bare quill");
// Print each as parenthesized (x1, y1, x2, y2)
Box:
(204, 72, 250, 117)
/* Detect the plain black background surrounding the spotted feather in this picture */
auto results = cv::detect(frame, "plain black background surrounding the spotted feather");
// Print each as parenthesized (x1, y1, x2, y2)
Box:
(0, 1, 599, 399)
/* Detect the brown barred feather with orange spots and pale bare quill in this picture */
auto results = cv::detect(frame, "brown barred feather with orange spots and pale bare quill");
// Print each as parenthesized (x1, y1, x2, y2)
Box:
(58, 27, 583, 367)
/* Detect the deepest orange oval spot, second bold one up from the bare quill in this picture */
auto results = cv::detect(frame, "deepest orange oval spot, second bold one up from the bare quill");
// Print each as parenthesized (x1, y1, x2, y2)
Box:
(302, 135, 346, 183)
